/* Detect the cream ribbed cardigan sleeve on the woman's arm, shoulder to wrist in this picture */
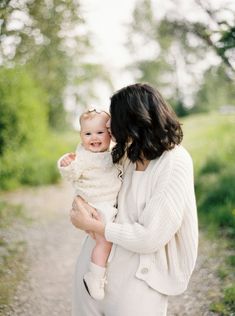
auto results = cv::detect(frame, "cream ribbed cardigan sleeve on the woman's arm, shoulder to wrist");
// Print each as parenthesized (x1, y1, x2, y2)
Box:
(105, 154, 193, 254)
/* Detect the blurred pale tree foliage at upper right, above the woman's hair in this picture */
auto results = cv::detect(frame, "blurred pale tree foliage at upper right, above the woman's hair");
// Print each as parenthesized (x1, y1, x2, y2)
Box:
(127, 0, 235, 113)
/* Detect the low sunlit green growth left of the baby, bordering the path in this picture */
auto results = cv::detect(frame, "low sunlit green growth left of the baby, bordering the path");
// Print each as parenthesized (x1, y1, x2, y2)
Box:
(0, 132, 79, 190)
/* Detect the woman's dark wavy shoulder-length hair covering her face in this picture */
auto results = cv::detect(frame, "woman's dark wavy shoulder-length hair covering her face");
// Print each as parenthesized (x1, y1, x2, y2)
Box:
(110, 83, 183, 163)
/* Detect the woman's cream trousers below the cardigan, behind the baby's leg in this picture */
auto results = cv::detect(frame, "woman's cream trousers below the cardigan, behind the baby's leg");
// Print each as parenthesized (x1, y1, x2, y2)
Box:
(72, 237, 168, 316)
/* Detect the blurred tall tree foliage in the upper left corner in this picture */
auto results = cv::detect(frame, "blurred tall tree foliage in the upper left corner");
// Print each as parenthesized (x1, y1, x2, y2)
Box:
(0, 0, 85, 128)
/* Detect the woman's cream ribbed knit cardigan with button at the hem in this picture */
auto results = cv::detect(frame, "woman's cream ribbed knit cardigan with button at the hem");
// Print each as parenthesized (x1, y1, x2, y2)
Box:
(105, 145, 198, 295)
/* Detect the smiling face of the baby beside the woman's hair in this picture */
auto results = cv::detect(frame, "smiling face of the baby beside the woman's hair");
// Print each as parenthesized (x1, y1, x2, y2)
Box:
(81, 114, 111, 153)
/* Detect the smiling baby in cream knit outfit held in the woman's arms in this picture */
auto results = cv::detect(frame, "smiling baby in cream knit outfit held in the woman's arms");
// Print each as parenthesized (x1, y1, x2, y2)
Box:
(58, 109, 122, 300)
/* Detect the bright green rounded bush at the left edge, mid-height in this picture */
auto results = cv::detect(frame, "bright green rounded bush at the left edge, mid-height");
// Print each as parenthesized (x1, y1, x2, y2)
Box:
(0, 67, 47, 155)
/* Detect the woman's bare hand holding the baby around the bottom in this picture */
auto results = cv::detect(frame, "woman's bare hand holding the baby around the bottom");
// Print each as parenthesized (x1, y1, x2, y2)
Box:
(70, 197, 104, 236)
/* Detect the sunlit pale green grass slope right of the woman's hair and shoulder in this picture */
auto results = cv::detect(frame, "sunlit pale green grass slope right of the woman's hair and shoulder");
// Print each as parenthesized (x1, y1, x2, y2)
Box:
(182, 113, 235, 175)
